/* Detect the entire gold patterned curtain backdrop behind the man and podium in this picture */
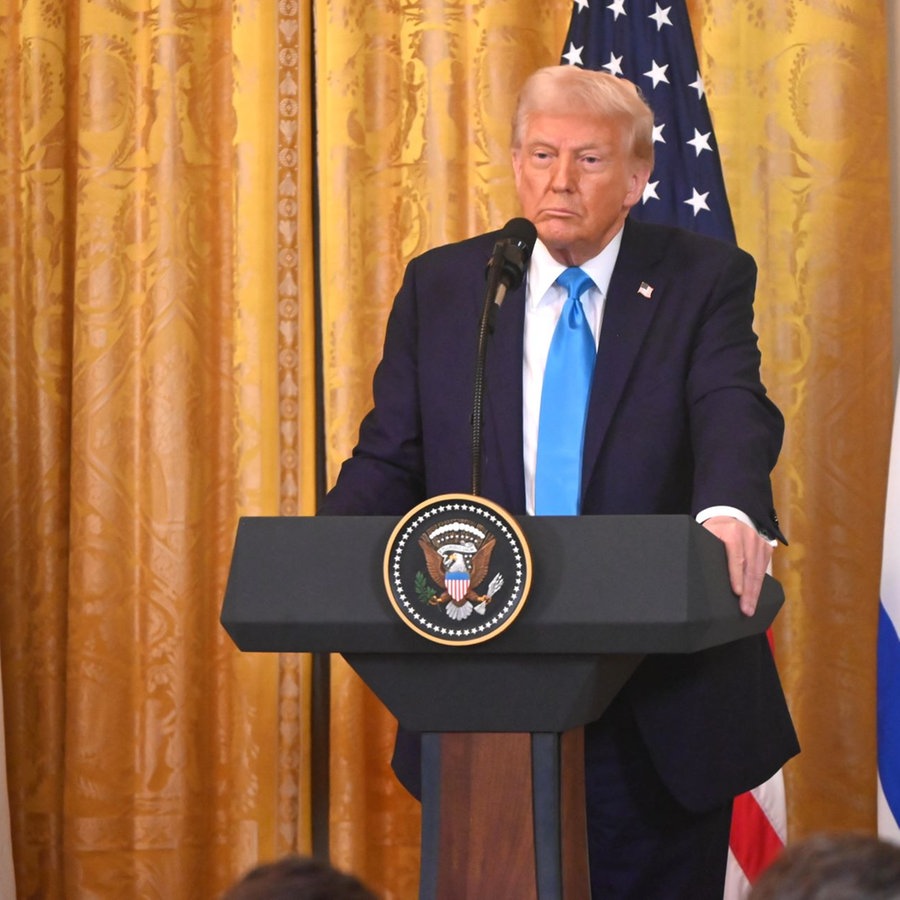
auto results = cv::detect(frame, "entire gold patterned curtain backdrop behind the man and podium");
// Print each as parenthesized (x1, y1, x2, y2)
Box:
(0, 0, 891, 898)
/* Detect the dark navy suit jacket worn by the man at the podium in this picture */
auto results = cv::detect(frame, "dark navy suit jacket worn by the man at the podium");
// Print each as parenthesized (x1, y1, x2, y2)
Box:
(320, 219, 798, 810)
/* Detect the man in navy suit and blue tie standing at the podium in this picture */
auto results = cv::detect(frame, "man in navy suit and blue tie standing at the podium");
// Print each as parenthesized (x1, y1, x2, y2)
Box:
(320, 66, 798, 900)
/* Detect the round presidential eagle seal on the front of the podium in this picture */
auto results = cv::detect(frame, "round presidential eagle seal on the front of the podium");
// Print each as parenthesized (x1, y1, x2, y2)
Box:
(384, 494, 531, 646)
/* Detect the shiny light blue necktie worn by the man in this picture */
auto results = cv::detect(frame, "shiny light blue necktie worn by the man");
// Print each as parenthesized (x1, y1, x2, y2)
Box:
(534, 268, 597, 516)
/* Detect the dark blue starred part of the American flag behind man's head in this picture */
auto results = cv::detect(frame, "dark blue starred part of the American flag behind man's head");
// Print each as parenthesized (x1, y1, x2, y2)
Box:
(562, 0, 734, 241)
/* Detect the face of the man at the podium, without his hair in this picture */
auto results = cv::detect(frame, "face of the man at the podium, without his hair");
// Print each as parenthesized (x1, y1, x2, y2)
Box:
(513, 113, 650, 266)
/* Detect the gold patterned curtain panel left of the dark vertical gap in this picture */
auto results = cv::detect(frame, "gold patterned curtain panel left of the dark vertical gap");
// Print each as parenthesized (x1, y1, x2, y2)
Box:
(0, 0, 314, 898)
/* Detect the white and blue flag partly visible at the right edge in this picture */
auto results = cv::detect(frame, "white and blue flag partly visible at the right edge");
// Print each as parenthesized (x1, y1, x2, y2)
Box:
(878, 388, 900, 843)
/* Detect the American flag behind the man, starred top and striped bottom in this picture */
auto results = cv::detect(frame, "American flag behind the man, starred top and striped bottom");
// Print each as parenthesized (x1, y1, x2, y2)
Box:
(562, 0, 787, 900)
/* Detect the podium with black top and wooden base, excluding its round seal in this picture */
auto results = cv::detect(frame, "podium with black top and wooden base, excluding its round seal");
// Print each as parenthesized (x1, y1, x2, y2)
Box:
(222, 516, 784, 900)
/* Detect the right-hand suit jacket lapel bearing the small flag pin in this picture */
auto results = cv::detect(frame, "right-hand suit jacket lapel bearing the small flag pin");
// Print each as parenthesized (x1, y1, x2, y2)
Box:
(582, 219, 664, 490)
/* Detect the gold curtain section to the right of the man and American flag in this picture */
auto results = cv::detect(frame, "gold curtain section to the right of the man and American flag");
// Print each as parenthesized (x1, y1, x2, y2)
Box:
(692, 0, 893, 837)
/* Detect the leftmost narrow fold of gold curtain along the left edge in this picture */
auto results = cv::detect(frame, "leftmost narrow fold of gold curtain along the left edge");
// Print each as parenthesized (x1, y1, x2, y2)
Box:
(0, 7, 78, 896)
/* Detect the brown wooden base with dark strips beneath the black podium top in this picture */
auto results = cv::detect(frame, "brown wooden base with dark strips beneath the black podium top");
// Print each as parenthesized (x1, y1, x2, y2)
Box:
(419, 728, 590, 900)
